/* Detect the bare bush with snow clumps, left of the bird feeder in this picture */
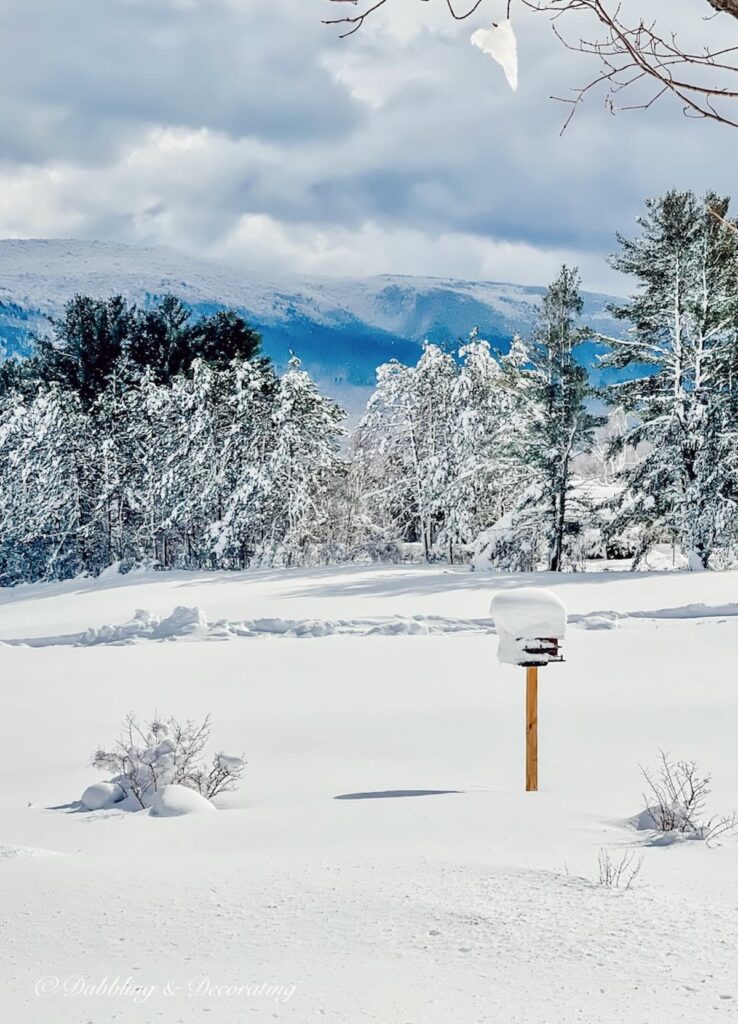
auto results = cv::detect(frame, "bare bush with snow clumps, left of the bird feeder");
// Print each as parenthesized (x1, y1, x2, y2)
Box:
(87, 714, 246, 807)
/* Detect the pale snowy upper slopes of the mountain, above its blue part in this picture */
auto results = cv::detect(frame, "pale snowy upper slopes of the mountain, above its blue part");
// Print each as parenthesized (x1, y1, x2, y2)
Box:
(0, 239, 605, 337)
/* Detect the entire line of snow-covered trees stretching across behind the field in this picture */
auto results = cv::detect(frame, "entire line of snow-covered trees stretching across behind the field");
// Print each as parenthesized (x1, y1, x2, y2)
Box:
(0, 191, 738, 585)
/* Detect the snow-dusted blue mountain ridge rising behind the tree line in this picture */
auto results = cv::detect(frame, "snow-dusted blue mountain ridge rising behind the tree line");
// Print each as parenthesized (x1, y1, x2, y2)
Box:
(0, 239, 618, 410)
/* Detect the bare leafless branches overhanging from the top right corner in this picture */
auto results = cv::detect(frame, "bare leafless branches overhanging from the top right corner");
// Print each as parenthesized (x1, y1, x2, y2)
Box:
(325, 0, 738, 131)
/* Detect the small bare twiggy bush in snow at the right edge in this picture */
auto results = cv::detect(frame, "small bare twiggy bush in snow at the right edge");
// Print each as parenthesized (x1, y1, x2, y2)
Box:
(639, 751, 738, 843)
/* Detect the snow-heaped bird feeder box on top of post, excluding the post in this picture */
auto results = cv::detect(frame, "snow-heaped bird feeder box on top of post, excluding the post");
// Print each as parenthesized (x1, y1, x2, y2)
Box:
(489, 587, 566, 666)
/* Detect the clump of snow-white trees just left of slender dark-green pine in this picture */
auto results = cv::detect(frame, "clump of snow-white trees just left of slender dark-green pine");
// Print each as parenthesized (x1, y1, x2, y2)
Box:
(355, 331, 524, 561)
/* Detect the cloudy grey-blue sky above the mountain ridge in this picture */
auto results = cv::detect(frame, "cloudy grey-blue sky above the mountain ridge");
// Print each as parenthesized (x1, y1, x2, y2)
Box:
(0, 0, 738, 291)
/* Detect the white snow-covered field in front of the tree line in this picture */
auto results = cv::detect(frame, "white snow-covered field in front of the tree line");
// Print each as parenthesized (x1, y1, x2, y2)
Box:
(0, 566, 738, 1024)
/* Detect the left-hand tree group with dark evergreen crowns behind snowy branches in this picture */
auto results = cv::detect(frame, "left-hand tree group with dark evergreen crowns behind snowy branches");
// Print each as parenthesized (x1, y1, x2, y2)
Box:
(0, 296, 343, 585)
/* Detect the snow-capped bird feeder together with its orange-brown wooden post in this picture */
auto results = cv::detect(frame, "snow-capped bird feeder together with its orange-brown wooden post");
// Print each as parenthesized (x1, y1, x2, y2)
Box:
(489, 587, 566, 793)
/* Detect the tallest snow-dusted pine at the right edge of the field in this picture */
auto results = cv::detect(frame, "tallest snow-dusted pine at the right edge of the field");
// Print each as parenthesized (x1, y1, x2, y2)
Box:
(606, 191, 738, 568)
